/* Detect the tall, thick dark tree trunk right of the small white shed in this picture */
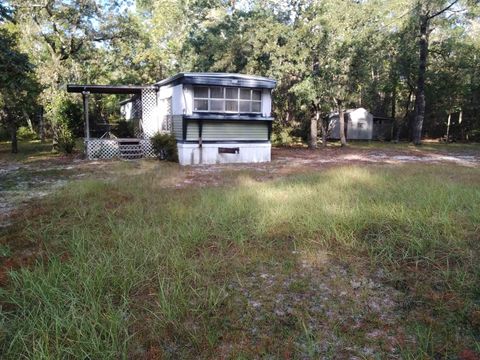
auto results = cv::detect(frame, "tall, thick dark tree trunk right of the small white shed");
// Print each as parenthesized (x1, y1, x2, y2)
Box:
(412, 15, 429, 145)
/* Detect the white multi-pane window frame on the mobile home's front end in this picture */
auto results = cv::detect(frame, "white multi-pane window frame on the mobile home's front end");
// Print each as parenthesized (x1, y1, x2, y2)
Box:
(192, 85, 263, 114)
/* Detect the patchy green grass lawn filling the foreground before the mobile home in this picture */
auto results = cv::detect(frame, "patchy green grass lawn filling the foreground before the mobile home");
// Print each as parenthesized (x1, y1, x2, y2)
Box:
(0, 165, 480, 359)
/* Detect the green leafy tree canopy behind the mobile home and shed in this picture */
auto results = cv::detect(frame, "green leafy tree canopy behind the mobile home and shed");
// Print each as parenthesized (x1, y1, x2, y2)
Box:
(0, 0, 480, 147)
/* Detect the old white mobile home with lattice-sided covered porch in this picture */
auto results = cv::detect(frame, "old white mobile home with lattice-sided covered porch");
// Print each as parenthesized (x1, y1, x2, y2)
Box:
(67, 73, 276, 165)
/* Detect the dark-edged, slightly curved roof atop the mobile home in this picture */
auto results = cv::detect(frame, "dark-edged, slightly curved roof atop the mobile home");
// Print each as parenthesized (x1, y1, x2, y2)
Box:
(156, 72, 277, 89)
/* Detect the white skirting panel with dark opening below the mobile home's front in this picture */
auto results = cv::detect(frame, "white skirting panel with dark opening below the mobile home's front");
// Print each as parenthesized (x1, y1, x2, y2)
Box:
(177, 142, 272, 165)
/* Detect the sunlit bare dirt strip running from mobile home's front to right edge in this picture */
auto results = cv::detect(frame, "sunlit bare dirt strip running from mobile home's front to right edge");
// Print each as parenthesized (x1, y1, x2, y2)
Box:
(174, 148, 480, 187)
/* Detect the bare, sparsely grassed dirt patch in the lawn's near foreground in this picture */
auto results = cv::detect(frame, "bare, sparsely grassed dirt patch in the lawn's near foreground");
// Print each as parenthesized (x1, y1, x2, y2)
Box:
(216, 251, 414, 359)
